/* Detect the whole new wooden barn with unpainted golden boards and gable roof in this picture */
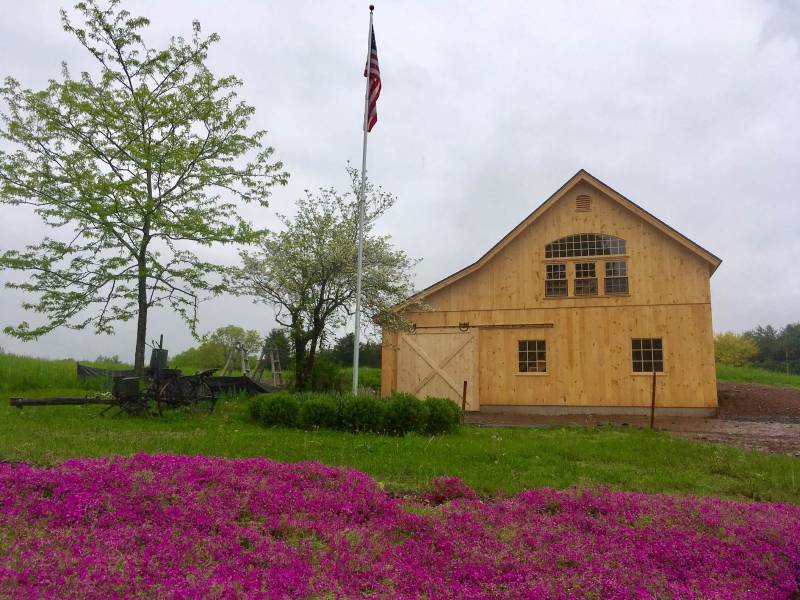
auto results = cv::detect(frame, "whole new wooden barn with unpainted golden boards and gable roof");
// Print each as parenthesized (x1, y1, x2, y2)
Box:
(381, 170, 721, 416)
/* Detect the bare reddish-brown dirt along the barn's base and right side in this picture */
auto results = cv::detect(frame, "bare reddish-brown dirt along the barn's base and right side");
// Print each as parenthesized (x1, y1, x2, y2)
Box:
(466, 382, 800, 456)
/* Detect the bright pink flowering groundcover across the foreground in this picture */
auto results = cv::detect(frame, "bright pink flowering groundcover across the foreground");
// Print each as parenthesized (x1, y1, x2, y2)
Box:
(0, 454, 800, 599)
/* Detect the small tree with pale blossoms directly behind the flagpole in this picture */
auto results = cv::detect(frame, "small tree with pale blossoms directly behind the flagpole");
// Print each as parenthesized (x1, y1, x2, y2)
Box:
(229, 167, 416, 390)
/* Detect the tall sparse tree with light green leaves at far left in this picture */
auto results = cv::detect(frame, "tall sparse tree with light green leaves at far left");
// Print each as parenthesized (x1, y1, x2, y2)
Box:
(0, 0, 288, 372)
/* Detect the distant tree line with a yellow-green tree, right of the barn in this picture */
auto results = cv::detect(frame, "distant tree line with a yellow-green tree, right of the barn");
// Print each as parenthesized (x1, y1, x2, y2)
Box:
(714, 323, 800, 375)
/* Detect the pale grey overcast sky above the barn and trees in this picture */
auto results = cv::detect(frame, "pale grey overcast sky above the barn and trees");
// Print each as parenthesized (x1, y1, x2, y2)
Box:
(0, 0, 800, 360)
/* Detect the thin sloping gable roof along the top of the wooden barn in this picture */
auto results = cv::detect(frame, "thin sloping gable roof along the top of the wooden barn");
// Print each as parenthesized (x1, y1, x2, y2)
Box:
(398, 169, 722, 308)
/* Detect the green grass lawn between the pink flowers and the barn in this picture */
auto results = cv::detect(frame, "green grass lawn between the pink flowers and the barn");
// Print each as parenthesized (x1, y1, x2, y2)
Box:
(0, 389, 800, 503)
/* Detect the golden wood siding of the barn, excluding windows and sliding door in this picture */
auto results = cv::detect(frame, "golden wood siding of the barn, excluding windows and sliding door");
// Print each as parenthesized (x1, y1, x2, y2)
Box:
(382, 176, 717, 407)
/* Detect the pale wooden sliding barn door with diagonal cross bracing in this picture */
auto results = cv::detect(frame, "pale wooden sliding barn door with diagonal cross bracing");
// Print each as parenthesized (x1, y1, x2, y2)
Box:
(397, 329, 479, 410)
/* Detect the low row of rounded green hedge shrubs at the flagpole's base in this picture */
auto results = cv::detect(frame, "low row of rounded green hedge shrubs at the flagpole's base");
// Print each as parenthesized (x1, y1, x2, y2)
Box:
(249, 392, 461, 435)
